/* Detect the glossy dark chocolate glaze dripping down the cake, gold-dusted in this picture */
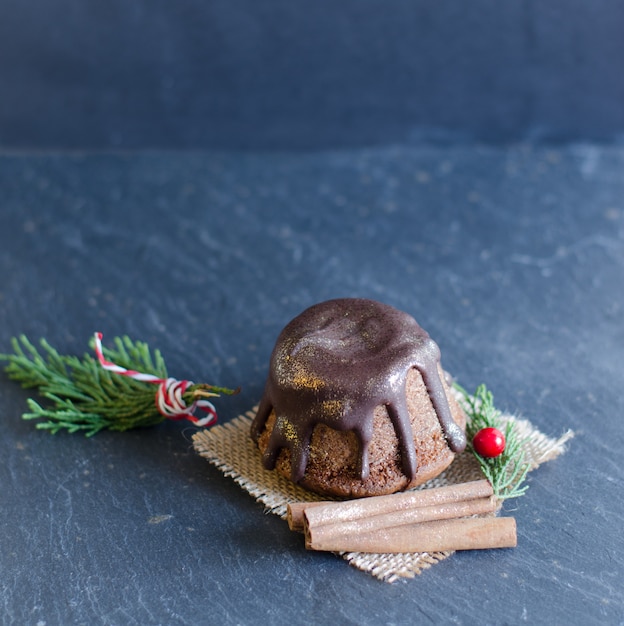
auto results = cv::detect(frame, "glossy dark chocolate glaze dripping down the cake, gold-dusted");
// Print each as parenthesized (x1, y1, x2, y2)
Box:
(251, 298, 466, 482)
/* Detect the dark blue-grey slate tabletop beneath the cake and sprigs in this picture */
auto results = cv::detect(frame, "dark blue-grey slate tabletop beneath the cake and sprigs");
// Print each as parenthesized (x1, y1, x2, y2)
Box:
(0, 144, 624, 626)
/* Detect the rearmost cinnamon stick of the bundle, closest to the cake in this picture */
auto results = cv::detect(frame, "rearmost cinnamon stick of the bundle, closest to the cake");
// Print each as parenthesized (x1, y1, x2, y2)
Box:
(296, 480, 493, 528)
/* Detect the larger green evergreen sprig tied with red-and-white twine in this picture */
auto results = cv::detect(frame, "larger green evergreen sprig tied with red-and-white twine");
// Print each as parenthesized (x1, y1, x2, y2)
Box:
(0, 335, 236, 436)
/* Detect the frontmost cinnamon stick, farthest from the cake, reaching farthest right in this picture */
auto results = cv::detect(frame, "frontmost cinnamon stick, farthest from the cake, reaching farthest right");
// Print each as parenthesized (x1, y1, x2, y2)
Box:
(306, 517, 517, 553)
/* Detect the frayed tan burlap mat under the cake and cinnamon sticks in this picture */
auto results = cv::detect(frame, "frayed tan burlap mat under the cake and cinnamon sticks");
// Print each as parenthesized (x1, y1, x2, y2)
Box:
(193, 398, 573, 582)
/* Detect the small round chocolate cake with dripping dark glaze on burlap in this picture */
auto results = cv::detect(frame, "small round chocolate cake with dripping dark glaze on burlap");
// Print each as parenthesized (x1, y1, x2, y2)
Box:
(251, 298, 466, 497)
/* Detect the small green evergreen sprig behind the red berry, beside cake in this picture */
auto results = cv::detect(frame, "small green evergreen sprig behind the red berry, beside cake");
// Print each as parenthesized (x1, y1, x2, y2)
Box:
(455, 384, 530, 500)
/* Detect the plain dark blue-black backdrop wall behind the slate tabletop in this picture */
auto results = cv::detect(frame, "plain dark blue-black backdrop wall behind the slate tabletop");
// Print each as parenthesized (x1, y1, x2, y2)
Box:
(0, 0, 624, 149)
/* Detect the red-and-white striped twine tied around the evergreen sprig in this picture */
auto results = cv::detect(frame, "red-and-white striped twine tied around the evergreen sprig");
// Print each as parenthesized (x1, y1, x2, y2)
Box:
(95, 333, 217, 426)
